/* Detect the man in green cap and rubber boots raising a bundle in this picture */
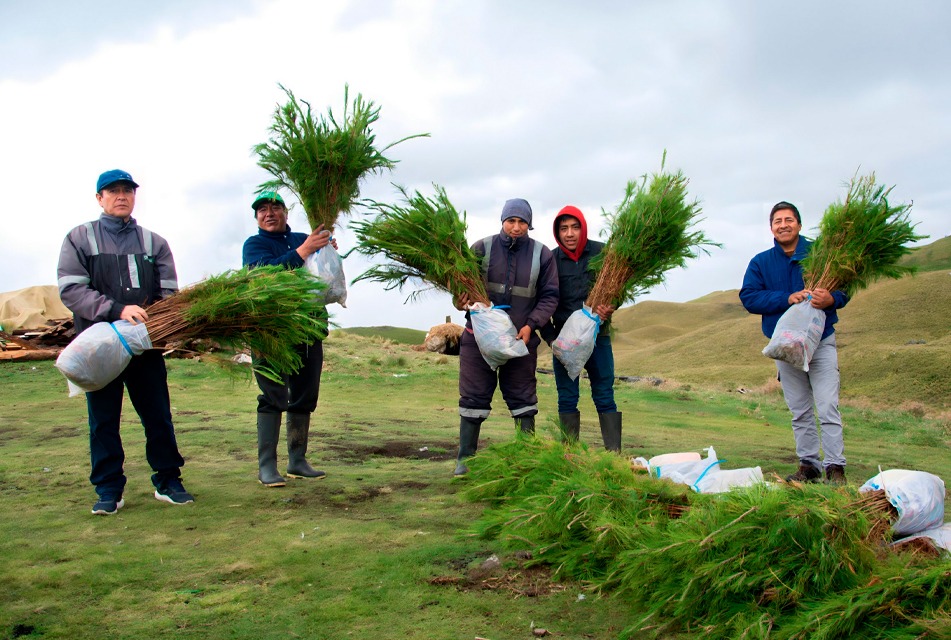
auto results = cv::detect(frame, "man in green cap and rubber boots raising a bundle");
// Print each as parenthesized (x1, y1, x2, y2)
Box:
(241, 191, 332, 487)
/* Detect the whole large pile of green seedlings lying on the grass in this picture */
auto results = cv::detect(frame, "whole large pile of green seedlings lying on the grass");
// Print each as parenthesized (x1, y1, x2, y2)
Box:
(467, 439, 951, 639)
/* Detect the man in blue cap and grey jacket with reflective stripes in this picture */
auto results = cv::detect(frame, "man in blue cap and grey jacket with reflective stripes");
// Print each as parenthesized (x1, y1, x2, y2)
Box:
(57, 169, 194, 515)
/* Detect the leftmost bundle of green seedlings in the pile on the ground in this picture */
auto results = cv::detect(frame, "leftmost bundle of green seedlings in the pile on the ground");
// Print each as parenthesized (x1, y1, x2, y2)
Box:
(465, 437, 694, 582)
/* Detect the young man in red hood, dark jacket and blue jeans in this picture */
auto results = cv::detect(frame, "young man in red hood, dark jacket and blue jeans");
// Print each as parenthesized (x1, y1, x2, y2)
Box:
(542, 205, 621, 451)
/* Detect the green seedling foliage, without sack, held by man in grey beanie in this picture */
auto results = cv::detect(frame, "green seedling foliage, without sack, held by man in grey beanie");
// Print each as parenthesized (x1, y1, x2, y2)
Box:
(350, 185, 489, 305)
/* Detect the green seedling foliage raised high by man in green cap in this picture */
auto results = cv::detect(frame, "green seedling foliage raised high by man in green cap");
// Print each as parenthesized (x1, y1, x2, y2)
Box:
(253, 85, 429, 230)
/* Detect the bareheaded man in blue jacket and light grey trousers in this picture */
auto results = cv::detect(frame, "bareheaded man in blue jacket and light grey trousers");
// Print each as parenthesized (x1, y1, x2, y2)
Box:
(740, 202, 849, 484)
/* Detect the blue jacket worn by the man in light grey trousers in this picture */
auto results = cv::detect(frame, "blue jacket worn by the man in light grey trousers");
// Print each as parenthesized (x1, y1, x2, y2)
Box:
(740, 236, 849, 339)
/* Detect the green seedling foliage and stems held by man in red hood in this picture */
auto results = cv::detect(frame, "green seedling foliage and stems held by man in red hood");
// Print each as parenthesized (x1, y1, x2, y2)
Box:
(585, 153, 720, 308)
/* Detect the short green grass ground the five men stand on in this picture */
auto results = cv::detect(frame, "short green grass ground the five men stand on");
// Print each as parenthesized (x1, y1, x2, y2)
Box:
(0, 331, 951, 640)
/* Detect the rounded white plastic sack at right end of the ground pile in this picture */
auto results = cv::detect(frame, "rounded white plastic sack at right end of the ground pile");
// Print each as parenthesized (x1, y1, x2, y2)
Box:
(859, 469, 944, 536)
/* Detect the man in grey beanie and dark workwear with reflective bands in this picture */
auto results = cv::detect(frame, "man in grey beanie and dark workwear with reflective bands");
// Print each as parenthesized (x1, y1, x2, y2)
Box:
(454, 198, 558, 476)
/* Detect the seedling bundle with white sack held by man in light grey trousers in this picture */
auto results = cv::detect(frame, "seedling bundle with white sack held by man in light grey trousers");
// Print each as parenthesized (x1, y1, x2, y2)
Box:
(763, 173, 926, 371)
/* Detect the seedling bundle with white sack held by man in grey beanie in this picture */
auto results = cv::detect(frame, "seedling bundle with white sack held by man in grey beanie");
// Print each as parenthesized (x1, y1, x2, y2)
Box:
(350, 185, 528, 369)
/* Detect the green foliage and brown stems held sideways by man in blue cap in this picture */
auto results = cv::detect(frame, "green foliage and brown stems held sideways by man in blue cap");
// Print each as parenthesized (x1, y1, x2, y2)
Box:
(145, 267, 327, 381)
